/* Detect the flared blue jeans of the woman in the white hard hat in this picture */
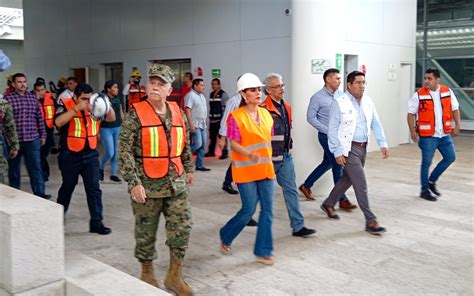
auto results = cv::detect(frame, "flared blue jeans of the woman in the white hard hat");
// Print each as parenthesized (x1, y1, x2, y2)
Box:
(219, 179, 275, 257)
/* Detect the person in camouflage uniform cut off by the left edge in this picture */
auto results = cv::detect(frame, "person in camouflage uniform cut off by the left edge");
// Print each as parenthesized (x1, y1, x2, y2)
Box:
(0, 99, 20, 184)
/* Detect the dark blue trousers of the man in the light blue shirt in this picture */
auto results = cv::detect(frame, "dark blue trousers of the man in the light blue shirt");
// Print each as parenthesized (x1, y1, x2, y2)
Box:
(304, 133, 347, 201)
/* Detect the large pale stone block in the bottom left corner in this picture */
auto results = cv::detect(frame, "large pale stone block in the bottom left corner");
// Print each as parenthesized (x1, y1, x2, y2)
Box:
(0, 184, 65, 296)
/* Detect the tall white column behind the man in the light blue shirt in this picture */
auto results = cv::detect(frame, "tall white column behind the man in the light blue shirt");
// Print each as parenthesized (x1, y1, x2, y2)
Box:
(291, 0, 345, 195)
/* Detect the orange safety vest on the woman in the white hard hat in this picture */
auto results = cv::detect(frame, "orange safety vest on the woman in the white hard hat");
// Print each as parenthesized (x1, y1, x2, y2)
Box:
(227, 107, 275, 183)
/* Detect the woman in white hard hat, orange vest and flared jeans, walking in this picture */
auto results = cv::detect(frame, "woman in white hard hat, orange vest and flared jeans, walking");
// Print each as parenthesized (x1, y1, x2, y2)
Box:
(220, 73, 275, 265)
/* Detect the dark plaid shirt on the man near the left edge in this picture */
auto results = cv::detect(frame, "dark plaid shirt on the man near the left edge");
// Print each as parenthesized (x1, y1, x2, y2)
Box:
(4, 91, 46, 142)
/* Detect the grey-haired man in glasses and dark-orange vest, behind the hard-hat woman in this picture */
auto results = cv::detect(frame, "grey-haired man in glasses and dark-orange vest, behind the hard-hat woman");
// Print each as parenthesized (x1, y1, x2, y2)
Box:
(261, 73, 316, 237)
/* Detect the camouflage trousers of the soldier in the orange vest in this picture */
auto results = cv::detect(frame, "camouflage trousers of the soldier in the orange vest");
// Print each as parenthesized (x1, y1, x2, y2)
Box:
(132, 193, 193, 261)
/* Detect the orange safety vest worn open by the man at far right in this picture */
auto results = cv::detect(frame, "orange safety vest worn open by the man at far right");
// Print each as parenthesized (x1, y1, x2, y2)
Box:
(418, 85, 453, 137)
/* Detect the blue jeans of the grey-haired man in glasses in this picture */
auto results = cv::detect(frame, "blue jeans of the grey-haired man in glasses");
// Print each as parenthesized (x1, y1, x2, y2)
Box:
(273, 152, 304, 232)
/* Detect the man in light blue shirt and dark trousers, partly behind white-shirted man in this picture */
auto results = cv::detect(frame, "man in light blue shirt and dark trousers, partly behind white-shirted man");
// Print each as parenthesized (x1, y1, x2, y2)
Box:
(299, 68, 357, 212)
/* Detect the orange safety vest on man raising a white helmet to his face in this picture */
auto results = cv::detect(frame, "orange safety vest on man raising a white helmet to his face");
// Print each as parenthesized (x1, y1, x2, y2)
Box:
(62, 99, 100, 152)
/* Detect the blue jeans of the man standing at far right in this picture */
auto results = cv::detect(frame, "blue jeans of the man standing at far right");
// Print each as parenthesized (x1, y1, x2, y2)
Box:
(418, 135, 456, 191)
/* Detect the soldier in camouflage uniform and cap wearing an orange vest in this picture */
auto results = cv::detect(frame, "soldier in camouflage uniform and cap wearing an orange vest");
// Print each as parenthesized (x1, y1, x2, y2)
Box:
(119, 64, 193, 295)
